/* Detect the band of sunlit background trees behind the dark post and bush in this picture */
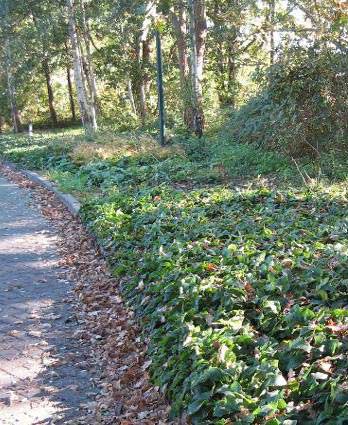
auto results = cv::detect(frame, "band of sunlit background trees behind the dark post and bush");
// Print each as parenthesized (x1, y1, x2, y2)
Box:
(0, 0, 348, 139)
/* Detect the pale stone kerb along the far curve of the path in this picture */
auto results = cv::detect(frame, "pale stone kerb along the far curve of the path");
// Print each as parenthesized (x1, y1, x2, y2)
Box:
(0, 160, 81, 217)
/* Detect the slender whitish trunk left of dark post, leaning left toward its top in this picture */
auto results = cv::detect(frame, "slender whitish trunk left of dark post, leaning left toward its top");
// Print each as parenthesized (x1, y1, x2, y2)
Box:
(66, 0, 98, 133)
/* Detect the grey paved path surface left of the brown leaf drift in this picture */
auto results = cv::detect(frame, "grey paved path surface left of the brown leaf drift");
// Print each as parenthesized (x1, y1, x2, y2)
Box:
(0, 176, 95, 425)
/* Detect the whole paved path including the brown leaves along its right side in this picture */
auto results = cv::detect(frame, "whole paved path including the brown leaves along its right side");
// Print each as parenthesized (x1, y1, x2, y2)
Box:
(0, 166, 167, 425)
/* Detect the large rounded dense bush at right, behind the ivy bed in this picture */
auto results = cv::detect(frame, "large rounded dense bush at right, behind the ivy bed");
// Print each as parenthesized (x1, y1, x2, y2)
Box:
(230, 48, 348, 155)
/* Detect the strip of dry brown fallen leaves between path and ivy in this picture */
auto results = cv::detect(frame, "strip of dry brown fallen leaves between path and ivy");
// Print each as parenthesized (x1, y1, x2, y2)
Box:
(0, 164, 174, 425)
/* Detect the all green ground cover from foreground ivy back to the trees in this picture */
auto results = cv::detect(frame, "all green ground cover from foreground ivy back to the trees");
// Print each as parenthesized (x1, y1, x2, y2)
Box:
(0, 128, 348, 425)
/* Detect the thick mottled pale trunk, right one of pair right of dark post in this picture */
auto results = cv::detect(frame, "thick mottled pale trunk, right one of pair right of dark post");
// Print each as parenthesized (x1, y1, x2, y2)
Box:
(189, 0, 207, 136)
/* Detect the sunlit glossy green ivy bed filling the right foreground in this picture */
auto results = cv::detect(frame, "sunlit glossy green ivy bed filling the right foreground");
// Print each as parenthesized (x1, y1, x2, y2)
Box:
(84, 184, 348, 425)
